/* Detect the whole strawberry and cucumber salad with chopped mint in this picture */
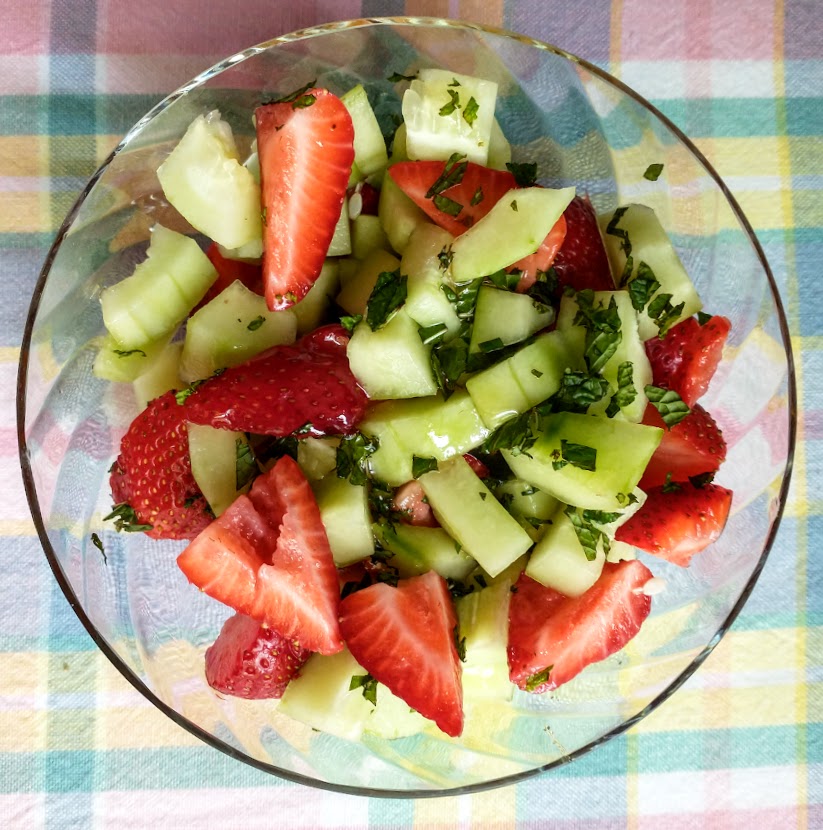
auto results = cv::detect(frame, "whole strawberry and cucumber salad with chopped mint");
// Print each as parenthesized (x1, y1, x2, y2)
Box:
(95, 69, 732, 739)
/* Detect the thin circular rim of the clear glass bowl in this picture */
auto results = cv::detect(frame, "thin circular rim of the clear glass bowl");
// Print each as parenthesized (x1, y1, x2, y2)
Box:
(16, 16, 797, 798)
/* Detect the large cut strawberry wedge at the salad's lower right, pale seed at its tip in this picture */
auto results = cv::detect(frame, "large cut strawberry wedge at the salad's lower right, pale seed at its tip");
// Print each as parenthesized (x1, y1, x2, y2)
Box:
(508, 559, 652, 692)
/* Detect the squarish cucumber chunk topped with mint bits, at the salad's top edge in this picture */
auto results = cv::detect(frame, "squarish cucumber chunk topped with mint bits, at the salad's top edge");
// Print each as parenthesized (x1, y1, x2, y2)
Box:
(403, 69, 498, 167)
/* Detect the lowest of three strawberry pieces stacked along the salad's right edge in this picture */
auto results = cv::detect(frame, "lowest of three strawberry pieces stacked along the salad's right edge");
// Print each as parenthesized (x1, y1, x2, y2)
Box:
(615, 481, 732, 568)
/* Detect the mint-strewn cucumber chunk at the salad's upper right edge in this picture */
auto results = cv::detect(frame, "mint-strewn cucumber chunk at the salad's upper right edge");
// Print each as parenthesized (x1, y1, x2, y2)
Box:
(599, 205, 703, 340)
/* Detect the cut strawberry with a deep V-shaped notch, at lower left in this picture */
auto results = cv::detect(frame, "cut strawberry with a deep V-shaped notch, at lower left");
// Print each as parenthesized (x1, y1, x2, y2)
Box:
(177, 456, 343, 654)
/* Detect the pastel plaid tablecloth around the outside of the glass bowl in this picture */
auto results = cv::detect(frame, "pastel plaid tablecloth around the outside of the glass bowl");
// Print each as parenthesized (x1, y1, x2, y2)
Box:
(0, 0, 823, 830)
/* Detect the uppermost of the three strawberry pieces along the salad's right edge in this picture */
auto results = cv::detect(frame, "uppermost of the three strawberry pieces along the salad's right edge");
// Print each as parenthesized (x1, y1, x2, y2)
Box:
(646, 315, 731, 406)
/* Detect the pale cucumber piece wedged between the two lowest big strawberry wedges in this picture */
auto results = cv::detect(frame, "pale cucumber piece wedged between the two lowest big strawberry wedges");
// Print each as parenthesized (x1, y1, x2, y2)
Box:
(454, 579, 514, 704)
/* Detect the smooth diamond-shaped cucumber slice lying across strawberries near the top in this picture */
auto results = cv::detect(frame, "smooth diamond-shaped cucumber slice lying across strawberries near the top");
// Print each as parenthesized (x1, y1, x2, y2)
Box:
(451, 187, 574, 282)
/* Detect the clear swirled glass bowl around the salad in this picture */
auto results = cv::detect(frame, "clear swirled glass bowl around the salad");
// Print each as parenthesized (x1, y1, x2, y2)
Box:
(14, 18, 795, 796)
